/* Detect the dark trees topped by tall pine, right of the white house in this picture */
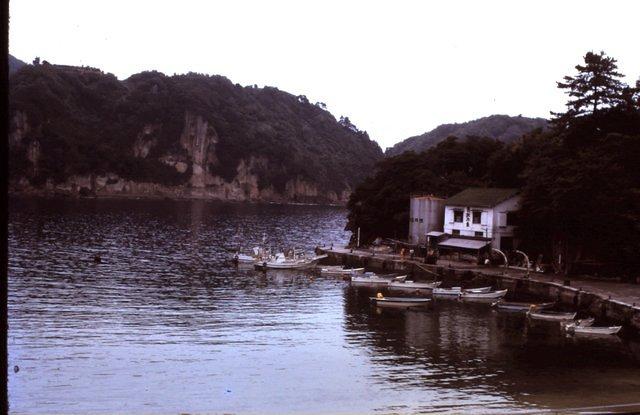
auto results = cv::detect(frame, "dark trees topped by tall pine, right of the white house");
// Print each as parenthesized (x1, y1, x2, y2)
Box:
(519, 53, 640, 272)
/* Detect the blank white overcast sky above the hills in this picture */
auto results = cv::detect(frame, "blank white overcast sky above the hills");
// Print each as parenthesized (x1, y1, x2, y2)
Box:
(9, 0, 640, 149)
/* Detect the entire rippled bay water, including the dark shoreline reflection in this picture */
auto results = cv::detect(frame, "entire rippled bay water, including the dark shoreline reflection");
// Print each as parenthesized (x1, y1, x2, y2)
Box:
(8, 200, 640, 414)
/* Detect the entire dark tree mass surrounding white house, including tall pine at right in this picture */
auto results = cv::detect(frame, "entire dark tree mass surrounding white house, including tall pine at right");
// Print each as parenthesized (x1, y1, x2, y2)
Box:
(347, 53, 640, 277)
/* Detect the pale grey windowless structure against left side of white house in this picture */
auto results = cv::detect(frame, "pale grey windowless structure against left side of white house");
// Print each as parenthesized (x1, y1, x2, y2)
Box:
(409, 195, 445, 244)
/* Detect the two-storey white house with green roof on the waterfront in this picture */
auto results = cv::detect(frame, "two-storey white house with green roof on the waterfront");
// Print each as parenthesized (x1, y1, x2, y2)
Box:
(444, 188, 520, 251)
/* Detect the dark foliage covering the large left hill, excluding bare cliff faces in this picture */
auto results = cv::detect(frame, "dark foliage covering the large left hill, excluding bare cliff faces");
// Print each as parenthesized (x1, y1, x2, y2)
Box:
(10, 61, 382, 193)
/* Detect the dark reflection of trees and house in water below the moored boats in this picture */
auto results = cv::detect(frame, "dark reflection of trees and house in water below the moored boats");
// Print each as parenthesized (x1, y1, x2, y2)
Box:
(345, 288, 640, 412)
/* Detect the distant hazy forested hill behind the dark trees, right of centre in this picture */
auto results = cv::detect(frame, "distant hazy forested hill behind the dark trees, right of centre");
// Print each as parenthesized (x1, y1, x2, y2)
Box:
(385, 115, 547, 156)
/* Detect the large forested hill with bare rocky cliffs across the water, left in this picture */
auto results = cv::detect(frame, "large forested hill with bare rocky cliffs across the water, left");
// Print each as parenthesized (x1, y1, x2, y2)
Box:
(10, 61, 382, 202)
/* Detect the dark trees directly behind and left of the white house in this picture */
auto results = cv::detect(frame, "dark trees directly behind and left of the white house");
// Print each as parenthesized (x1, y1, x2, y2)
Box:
(347, 137, 527, 243)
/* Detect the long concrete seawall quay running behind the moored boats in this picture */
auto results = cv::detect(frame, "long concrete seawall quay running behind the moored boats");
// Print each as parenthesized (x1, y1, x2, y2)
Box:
(318, 248, 640, 333)
